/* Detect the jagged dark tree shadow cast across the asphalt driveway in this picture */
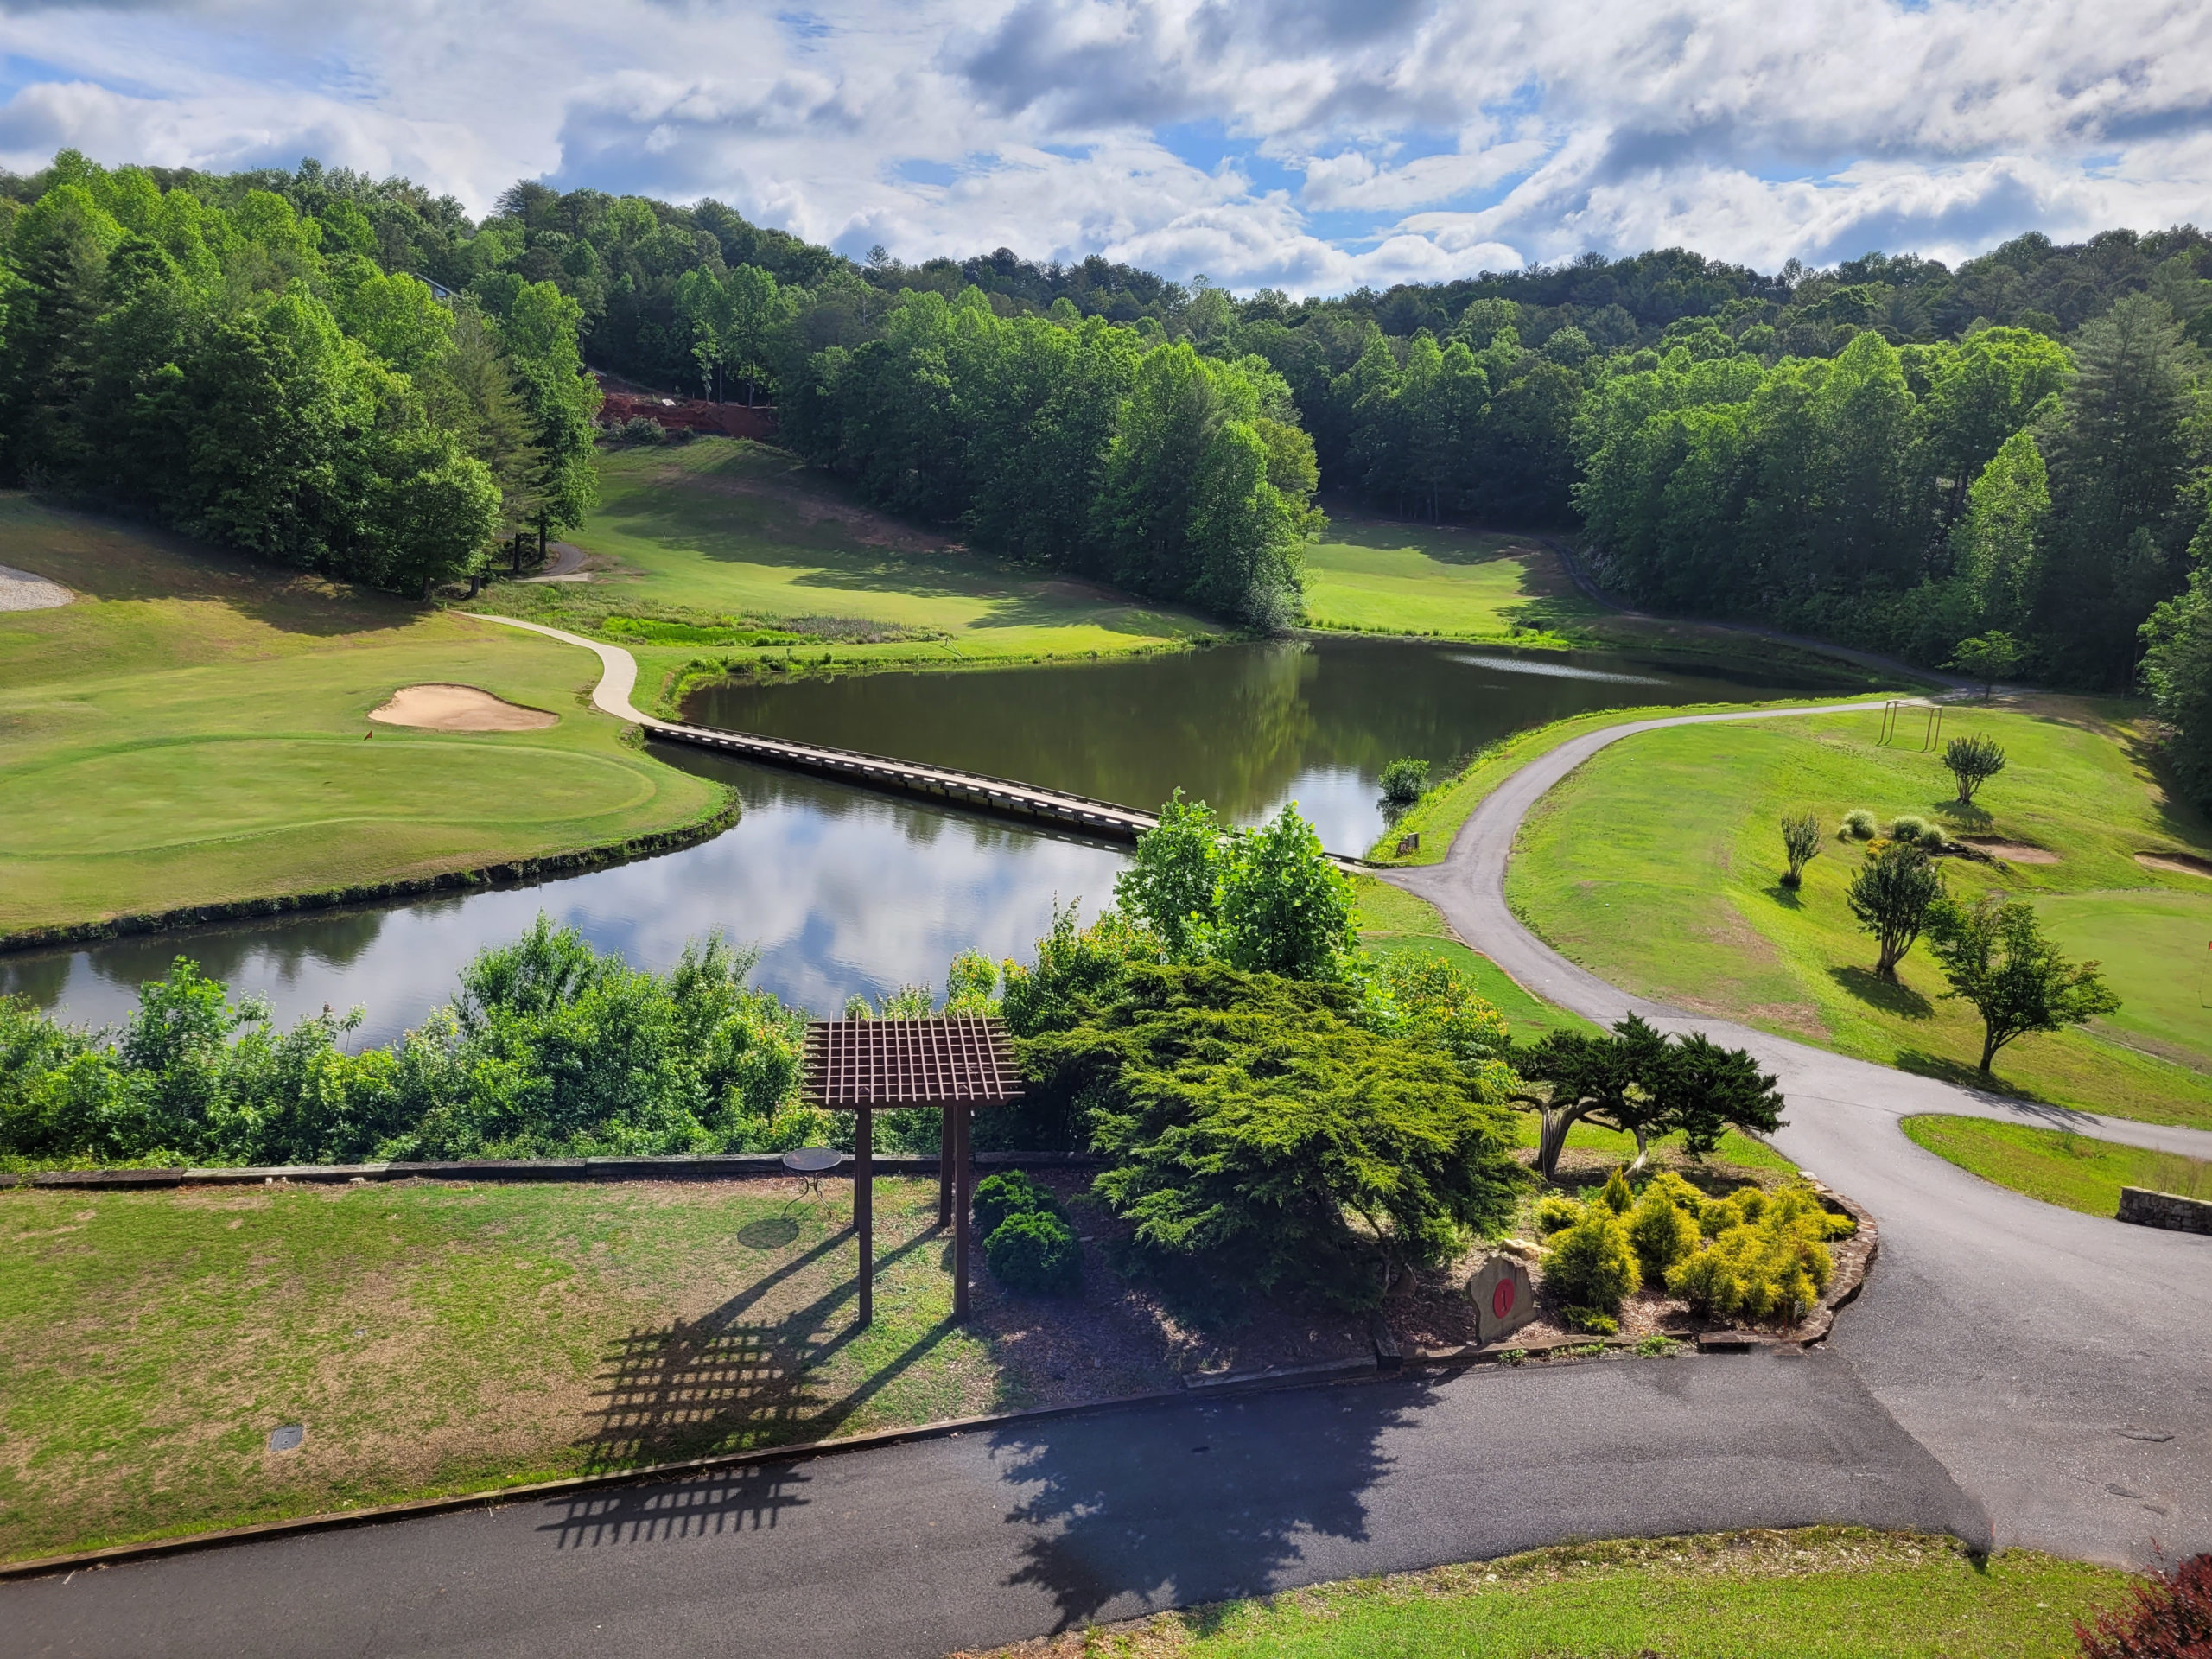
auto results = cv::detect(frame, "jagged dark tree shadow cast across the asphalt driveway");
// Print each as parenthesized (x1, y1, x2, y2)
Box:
(991, 1385, 1433, 1630)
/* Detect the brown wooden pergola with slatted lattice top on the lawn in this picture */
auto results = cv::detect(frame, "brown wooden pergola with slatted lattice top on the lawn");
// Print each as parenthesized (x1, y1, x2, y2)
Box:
(798, 1013, 1022, 1325)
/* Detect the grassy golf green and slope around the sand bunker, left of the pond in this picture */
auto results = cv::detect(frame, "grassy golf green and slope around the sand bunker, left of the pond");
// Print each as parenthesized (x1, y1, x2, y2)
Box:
(0, 493, 721, 931)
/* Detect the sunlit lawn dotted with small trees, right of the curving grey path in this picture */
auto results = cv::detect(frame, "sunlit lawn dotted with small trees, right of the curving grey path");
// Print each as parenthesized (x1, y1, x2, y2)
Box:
(1506, 699, 2212, 1126)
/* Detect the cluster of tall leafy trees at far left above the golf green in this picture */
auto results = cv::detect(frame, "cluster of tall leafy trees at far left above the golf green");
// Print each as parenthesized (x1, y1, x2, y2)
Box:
(0, 153, 597, 595)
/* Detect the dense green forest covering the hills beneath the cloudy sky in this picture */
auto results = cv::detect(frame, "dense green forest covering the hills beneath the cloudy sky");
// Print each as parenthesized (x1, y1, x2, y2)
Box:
(13, 153, 2212, 798)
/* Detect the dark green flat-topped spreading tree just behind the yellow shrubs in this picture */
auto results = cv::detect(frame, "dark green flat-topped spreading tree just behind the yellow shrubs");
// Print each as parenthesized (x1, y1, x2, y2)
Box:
(1513, 1013, 1783, 1181)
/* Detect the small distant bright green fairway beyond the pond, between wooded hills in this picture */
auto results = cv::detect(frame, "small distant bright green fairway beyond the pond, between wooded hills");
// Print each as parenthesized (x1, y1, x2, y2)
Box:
(1305, 515, 1604, 651)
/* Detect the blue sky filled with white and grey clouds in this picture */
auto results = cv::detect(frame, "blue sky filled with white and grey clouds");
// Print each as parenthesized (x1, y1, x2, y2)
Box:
(0, 0, 2212, 294)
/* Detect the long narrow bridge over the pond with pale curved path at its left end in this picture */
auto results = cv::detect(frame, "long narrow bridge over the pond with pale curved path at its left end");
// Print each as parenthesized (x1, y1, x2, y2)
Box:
(482, 615, 1370, 872)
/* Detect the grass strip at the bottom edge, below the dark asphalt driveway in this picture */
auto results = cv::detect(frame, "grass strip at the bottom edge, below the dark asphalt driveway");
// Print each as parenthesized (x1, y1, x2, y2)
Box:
(956, 1529, 2128, 1659)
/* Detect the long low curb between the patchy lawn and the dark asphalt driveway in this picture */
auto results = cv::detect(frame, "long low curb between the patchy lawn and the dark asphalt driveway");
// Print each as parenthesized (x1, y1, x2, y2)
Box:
(0, 1360, 1376, 1584)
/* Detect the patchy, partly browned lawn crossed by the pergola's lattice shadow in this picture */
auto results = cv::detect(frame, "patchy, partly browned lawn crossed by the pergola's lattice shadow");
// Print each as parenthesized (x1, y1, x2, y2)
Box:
(0, 1179, 1166, 1560)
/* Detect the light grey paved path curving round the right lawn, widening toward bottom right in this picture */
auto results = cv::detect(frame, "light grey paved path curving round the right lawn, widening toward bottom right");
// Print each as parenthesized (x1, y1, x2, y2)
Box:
(1387, 703, 2212, 1561)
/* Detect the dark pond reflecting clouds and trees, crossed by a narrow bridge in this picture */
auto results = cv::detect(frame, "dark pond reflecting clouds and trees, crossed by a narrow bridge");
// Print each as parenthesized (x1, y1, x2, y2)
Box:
(0, 637, 1812, 1042)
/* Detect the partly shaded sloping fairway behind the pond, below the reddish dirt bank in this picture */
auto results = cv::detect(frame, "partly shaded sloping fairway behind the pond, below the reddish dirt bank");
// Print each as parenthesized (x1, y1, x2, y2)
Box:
(478, 438, 1224, 712)
